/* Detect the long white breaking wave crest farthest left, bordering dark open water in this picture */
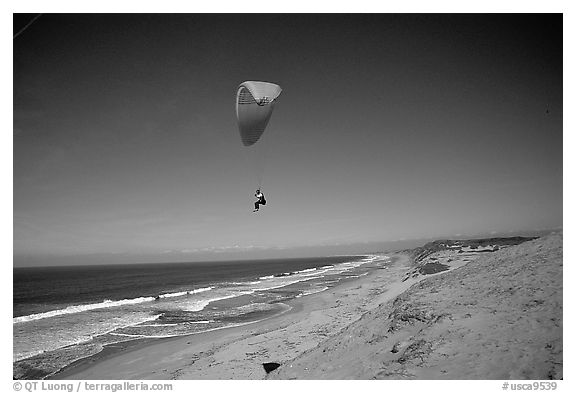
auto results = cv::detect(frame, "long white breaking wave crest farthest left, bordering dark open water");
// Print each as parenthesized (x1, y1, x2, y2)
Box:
(12, 287, 213, 324)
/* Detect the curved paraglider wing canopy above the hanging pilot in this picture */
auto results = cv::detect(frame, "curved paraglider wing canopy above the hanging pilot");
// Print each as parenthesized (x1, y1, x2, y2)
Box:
(236, 81, 282, 146)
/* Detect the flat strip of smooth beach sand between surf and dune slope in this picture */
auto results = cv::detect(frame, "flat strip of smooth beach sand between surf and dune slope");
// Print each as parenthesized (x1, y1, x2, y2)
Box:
(46, 254, 417, 379)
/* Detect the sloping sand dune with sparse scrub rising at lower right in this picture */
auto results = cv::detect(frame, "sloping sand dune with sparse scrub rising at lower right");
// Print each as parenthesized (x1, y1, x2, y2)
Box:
(270, 234, 562, 379)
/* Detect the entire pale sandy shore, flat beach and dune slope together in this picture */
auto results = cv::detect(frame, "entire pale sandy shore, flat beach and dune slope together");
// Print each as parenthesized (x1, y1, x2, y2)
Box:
(46, 234, 563, 379)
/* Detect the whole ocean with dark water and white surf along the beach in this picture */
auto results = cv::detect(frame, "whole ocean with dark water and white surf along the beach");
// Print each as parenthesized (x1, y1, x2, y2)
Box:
(13, 255, 387, 374)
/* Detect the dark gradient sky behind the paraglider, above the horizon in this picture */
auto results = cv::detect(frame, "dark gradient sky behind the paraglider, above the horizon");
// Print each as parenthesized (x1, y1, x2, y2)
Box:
(13, 14, 563, 265)
